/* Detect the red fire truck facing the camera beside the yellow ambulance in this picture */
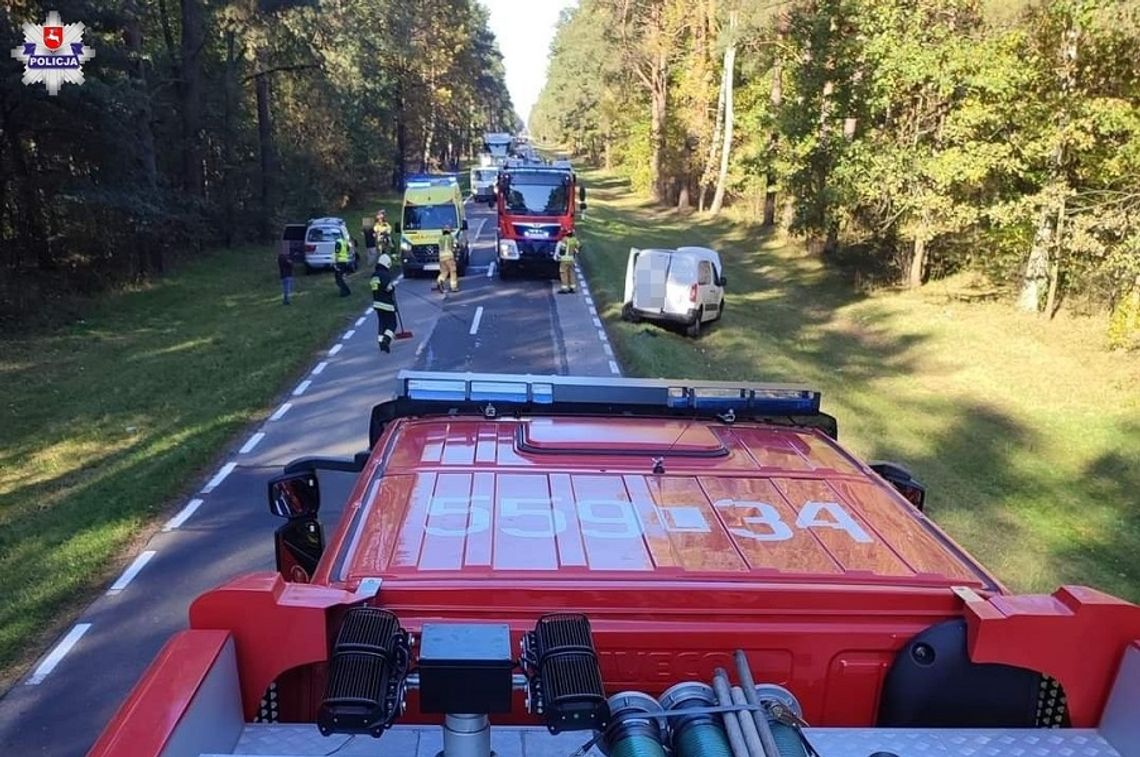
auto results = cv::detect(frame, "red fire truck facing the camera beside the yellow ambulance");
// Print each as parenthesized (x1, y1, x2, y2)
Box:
(495, 161, 586, 278)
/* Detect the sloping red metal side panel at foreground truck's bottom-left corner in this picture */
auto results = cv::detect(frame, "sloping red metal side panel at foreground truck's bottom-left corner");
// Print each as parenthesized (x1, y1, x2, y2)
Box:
(88, 630, 230, 757)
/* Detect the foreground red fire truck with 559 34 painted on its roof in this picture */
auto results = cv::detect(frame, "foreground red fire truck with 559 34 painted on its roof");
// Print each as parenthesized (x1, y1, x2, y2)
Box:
(92, 373, 1140, 757)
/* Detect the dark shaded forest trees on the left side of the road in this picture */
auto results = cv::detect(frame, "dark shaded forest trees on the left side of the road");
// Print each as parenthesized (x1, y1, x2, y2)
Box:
(0, 0, 519, 318)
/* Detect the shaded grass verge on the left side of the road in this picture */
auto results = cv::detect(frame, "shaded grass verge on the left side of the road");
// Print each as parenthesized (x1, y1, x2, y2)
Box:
(0, 194, 398, 691)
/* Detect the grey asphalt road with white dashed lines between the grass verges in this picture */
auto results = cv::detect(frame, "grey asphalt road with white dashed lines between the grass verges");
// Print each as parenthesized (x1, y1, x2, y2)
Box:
(0, 198, 618, 757)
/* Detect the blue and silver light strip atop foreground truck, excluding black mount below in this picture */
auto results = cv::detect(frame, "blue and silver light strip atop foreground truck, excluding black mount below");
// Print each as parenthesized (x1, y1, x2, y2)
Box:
(397, 371, 821, 415)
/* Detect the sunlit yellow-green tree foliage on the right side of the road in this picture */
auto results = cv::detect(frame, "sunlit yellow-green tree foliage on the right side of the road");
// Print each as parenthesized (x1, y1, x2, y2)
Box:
(535, 0, 1140, 335)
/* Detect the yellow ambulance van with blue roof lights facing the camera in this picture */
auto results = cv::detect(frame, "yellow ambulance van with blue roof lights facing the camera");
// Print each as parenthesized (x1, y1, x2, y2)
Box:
(392, 174, 471, 276)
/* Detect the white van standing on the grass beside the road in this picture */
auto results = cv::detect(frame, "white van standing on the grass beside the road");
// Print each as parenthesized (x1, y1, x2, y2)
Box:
(621, 247, 726, 337)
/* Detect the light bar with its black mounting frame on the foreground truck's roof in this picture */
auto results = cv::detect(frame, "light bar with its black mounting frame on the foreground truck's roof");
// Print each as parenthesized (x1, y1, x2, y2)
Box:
(369, 371, 837, 445)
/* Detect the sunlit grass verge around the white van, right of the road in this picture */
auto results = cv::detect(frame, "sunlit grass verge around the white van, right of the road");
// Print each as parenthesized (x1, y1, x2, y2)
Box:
(581, 173, 1140, 601)
